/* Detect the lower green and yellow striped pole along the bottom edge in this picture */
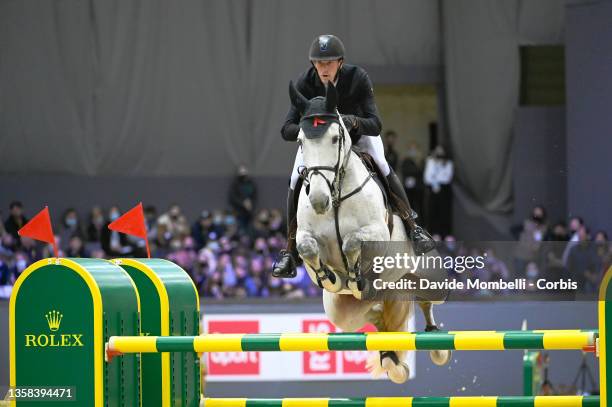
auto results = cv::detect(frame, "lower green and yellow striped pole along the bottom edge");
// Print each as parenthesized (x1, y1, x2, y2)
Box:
(204, 396, 599, 407)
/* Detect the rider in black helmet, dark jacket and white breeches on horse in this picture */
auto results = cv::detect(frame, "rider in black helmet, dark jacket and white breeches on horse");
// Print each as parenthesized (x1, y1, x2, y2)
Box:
(272, 35, 434, 278)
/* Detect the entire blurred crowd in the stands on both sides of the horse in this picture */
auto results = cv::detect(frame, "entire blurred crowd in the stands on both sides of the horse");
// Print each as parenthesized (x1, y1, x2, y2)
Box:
(0, 202, 612, 299)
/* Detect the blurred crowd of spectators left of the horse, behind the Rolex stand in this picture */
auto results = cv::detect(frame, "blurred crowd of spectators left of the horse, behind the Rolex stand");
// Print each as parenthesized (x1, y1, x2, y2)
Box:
(0, 202, 320, 299)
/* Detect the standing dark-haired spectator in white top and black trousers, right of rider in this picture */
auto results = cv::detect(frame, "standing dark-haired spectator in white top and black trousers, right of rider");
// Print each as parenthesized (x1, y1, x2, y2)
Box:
(423, 145, 454, 236)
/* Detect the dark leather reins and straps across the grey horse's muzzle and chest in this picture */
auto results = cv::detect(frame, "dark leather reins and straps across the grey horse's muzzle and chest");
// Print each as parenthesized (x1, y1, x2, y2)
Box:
(299, 115, 372, 273)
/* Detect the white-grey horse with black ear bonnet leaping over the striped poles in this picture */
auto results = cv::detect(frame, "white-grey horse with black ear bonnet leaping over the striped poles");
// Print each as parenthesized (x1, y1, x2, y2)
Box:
(289, 82, 451, 383)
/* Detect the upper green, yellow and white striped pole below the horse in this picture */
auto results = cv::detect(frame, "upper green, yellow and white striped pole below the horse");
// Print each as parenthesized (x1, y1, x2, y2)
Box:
(106, 330, 597, 360)
